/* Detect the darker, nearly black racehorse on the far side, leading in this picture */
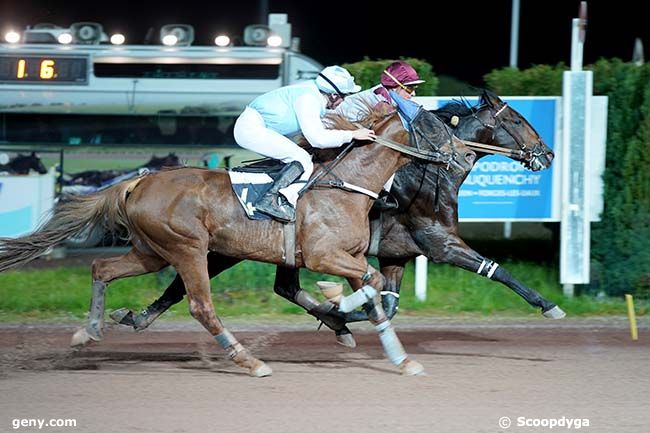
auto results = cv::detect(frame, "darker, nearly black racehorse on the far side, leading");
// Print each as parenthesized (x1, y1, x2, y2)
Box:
(111, 91, 564, 346)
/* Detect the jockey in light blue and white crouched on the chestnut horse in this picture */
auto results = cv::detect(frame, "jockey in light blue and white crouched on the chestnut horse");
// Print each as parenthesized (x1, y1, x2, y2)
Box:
(234, 66, 375, 221)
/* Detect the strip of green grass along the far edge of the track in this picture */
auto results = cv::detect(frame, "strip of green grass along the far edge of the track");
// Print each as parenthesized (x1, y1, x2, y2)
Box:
(0, 261, 649, 321)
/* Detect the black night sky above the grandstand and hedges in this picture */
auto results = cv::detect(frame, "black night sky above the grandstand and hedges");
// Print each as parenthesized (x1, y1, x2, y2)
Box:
(0, 0, 650, 85)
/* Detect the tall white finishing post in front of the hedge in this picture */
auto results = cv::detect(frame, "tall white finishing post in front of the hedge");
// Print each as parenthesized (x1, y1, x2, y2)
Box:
(560, 1, 593, 296)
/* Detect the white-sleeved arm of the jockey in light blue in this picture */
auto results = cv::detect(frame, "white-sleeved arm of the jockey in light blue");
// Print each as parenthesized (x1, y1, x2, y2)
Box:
(294, 94, 354, 149)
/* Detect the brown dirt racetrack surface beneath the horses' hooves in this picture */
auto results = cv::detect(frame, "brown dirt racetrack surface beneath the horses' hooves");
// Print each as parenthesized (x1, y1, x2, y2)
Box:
(0, 318, 650, 433)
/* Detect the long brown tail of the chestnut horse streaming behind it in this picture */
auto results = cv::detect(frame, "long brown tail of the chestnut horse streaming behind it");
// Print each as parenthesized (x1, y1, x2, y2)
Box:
(0, 178, 141, 272)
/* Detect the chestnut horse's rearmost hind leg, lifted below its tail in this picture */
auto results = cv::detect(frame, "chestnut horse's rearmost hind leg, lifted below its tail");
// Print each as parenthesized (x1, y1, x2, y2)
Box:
(71, 248, 167, 346)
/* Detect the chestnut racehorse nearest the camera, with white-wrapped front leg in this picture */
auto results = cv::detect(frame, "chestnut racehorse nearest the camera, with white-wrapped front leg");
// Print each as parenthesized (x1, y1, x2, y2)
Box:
(0, 110, 476, 376)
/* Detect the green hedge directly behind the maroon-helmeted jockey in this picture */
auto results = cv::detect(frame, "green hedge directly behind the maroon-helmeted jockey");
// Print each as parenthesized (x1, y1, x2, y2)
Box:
(341, 57, 438, 96)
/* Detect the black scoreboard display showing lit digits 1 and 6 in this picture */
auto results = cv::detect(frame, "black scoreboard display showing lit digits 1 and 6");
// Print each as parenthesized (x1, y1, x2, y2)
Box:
(0, 54, 88, 84)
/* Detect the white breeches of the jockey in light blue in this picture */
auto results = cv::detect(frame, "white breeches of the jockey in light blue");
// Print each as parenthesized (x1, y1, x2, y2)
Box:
(233, 107, 314, 206)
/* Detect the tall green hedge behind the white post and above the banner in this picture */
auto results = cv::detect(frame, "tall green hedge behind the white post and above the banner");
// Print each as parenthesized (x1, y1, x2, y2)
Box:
(484, 59, 650, 297)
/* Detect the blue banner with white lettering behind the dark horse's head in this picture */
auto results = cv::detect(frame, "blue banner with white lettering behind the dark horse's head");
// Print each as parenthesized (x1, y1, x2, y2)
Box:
(437, 97, 557, 221)
